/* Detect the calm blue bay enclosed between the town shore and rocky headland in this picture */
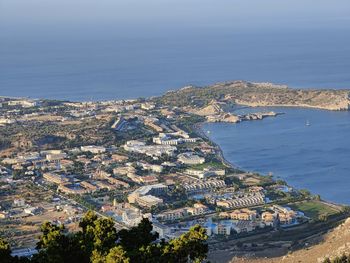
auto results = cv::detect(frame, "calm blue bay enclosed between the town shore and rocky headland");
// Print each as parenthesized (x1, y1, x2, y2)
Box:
(203, 108, 350, 204)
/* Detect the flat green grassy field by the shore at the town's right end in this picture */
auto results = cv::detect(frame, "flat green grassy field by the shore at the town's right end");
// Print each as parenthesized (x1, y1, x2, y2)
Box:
(290, 201, 338, 219)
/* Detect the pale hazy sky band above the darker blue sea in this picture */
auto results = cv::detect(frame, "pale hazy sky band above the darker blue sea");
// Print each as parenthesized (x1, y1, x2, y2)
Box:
(0, 0, 350, 34)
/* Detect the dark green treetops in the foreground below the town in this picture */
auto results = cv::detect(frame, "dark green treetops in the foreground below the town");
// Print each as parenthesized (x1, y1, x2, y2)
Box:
(0, 211, 208, 263)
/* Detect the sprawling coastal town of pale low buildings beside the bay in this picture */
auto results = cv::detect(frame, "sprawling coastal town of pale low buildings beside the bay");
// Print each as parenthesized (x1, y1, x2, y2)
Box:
(0, 97, 342, 256)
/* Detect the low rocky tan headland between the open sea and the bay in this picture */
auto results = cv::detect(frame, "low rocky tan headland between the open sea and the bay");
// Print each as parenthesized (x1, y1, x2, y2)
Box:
(160, 81, 350, 110)
